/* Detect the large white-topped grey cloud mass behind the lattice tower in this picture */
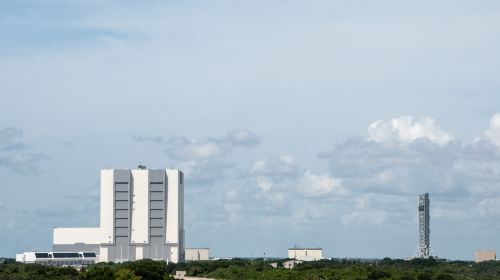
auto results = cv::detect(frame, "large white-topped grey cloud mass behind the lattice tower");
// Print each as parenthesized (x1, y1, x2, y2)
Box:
(316, 114, 500, 233)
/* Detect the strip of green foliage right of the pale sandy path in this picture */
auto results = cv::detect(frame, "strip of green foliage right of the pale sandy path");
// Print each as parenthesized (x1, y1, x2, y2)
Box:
(167, 258, 500, 280)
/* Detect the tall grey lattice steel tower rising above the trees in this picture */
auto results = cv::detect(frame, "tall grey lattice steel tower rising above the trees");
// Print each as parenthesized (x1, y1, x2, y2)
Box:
(417, 193, 432, 259)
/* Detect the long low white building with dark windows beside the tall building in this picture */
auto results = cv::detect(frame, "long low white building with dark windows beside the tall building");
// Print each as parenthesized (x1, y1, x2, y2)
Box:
(16, 252, 98, 267)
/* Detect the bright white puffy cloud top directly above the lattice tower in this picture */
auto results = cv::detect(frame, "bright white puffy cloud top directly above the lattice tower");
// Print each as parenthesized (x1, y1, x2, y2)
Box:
(367, 116, 453, 145)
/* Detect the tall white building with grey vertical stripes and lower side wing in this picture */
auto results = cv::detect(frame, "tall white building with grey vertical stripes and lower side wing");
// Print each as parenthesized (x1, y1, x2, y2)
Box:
(53, 166, 184, 263)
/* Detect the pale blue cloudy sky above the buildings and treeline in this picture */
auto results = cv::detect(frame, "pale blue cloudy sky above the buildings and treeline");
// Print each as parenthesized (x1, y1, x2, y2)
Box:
(0, 0, 500, 259)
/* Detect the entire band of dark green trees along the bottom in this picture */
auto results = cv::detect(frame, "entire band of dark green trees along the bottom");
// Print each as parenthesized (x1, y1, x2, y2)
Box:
(0, 259, 500, 280)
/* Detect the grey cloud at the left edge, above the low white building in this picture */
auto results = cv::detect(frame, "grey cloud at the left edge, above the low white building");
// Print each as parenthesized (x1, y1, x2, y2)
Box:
(0, 127, 48, 174)
